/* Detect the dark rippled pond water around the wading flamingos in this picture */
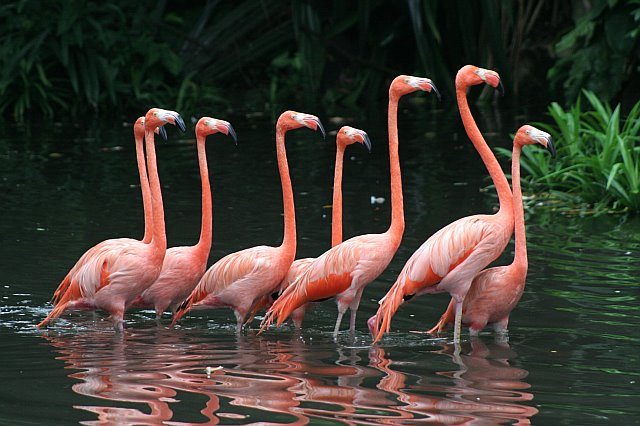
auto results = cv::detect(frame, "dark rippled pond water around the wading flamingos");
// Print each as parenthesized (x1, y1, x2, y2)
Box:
(0, 102, 640, 425)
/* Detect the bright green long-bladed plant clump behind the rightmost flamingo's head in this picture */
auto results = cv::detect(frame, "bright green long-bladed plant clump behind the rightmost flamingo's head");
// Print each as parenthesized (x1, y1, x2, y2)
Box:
(501, 90, 640, 213)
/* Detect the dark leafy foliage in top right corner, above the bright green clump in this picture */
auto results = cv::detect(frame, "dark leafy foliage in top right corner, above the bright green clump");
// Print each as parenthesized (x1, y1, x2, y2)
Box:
(548, 0, 640, 101)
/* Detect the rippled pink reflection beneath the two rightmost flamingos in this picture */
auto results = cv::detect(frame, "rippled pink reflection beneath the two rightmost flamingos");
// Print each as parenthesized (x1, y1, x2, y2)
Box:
(369, 337, 538, 425)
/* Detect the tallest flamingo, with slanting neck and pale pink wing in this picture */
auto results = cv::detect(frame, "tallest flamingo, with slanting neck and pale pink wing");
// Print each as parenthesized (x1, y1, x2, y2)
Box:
(367, 65, 514, 343)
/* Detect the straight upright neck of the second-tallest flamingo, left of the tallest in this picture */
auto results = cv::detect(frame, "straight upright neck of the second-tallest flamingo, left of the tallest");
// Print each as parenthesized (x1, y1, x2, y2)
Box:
(388, 93, 404, 243)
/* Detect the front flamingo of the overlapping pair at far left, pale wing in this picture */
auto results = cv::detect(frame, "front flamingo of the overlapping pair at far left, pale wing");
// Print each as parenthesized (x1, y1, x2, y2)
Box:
(38, 108, 185, 331)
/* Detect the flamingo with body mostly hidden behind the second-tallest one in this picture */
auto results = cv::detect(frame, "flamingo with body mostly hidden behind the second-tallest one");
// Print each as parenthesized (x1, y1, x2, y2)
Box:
(264, 126, 371, 329)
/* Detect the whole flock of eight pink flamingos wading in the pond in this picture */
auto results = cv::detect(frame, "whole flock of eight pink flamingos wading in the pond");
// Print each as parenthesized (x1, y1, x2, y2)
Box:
(38, 65, 555, 343)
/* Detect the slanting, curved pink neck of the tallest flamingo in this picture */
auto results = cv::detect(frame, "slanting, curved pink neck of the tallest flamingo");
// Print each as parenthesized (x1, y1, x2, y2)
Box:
(456, 86, 513, 216)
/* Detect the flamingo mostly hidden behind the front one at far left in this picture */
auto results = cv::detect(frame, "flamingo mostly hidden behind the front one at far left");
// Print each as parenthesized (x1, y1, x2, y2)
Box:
(51, 117, 167, 304)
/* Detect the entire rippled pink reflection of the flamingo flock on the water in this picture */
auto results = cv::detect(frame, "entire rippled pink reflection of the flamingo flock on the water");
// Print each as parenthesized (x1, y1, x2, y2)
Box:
(43, 327, 537, 424)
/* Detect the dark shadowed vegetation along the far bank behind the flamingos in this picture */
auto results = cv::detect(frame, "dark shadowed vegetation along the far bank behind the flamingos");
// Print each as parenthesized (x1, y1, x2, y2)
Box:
(0, 0, 640, 120)
